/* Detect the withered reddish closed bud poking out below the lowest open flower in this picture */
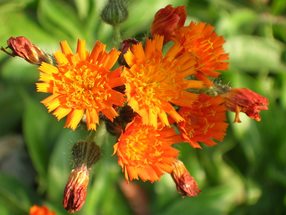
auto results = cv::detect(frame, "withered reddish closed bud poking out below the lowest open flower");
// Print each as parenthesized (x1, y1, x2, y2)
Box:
(171, 160, 201, 197)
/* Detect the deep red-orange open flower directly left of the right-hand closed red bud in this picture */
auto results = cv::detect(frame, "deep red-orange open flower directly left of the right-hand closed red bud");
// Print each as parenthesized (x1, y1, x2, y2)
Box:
(178, 94, 227, 148)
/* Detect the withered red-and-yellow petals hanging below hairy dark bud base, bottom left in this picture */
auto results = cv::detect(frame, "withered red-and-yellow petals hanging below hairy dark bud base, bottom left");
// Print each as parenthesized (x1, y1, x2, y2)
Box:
(63, 165, 89, 213)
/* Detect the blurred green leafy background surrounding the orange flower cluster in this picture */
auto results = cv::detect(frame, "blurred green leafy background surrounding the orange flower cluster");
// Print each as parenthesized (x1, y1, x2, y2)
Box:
(0, 0, 286, 215)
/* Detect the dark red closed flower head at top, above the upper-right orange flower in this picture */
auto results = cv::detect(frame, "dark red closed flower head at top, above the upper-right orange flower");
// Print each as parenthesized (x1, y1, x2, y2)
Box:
(151, 5, 187, 43)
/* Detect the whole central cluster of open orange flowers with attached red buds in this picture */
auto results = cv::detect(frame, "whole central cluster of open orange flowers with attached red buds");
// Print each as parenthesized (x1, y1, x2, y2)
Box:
(1, 5, 268, 215)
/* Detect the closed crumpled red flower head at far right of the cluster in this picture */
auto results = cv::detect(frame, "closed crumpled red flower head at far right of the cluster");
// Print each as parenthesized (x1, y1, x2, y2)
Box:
(222, 88, 268, 122)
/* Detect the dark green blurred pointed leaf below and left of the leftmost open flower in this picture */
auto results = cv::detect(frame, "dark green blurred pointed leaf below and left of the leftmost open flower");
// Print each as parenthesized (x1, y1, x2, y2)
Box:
(23, 96, 63, 189)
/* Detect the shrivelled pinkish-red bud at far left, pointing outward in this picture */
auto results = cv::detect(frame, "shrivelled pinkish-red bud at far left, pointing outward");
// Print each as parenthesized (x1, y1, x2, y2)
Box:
(1, 36, 54, 65)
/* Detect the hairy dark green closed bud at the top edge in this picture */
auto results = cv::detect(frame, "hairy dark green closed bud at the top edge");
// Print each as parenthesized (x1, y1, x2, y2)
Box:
(101, 0, 128, 26)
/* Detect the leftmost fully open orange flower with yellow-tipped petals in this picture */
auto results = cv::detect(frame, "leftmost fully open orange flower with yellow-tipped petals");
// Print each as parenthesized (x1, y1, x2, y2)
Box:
(37, 40, 124, 130)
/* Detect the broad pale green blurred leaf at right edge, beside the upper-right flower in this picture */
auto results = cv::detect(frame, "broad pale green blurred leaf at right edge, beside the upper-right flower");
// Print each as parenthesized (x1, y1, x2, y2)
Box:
(225, 35, 286, 72)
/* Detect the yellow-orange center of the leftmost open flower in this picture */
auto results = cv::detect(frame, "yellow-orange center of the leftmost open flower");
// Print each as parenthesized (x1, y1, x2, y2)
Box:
(55, 62, 111, 109)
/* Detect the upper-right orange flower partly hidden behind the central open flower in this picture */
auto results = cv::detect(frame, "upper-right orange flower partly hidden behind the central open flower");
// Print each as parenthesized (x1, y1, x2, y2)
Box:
(174, 22, 228, 85)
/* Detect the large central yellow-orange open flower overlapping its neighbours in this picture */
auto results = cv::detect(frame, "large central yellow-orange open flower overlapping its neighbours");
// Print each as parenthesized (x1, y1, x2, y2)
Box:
(122, 35, 202, 127)
